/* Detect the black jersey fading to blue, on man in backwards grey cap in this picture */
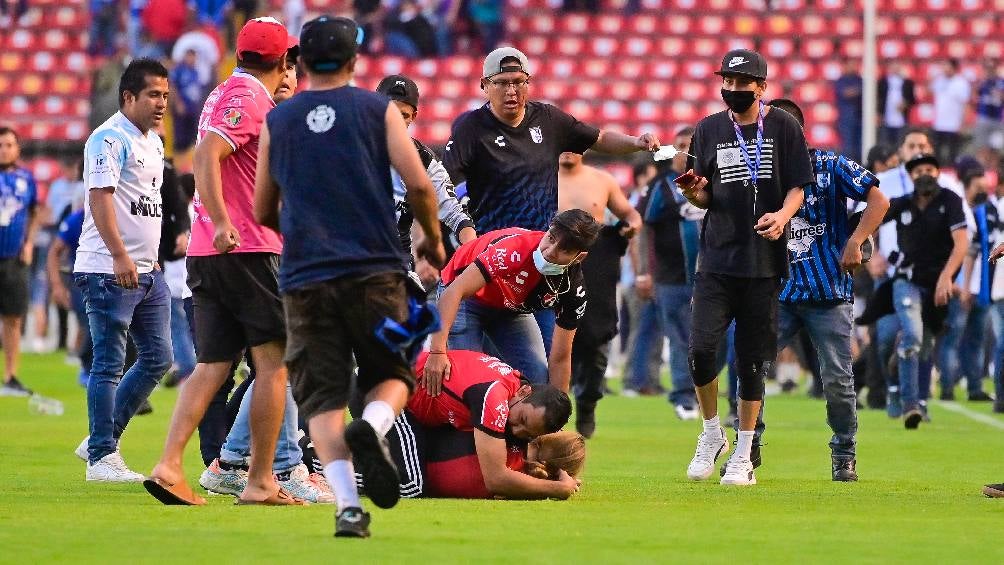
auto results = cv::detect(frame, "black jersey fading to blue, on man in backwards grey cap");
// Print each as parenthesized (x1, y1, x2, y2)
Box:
(443, 101, 599, 234)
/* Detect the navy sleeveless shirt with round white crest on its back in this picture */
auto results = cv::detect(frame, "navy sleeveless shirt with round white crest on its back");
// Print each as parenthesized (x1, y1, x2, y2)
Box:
(265, 86, 408, 292)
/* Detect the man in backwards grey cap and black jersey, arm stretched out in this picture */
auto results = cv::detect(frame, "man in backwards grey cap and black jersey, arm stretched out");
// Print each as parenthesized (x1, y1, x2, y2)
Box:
(443, 47, 659, 234)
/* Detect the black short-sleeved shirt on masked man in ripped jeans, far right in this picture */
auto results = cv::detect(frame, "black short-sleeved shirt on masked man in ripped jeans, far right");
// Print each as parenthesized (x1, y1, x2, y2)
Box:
(885, 189, 966, 290)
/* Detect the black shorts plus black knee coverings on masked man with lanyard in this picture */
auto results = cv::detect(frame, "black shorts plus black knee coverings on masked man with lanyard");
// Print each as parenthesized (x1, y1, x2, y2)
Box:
(690, 273, 781, 400)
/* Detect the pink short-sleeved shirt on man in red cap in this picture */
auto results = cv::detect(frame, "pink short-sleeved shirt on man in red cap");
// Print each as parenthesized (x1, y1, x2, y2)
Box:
(188, 71, 282, 257)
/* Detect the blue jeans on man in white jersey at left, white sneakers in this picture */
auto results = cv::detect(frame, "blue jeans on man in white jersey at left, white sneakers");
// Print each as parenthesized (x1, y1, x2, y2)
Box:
(74, 270, 172, 463)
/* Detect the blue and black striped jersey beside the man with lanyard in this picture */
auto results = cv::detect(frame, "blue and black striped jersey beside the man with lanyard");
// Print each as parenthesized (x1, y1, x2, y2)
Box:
(780, 150, 879, 304)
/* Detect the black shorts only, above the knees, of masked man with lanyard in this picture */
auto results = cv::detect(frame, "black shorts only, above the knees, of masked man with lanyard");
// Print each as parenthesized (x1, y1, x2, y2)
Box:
(690, 273, 781, 365)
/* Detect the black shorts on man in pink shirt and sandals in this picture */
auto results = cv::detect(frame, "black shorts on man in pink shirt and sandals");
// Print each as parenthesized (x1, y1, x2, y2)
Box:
(187, 253, 286, 363)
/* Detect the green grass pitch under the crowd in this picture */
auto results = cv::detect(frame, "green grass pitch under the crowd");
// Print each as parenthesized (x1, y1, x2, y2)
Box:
(0, 355, 1004, 563)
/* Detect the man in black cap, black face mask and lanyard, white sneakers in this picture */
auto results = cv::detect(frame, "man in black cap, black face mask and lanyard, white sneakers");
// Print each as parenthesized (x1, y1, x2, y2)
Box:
(678, 49, 814, 485)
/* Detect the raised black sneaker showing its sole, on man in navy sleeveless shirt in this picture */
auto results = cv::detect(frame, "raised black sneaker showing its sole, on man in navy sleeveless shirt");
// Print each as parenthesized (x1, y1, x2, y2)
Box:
(345, 418, 401, 508)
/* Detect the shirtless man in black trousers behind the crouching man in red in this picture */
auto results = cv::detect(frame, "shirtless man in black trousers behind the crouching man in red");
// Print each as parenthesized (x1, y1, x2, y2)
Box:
(558, 153, 642, 438)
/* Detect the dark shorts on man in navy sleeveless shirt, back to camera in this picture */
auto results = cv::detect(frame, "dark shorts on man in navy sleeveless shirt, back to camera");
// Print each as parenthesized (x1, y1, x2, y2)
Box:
(283, 272, 415, 419)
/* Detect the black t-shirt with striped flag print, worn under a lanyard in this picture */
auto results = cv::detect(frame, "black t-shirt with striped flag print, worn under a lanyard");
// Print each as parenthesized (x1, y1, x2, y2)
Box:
(690, 109, 814, 277)
